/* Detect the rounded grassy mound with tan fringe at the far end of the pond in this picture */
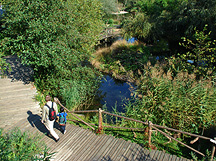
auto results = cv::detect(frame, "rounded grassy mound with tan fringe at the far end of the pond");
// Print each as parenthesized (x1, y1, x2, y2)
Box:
(92, 40, 156, 80)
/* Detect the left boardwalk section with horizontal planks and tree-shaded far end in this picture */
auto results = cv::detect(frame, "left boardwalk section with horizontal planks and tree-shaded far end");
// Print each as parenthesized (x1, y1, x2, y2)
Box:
(0, 56, 40, 128)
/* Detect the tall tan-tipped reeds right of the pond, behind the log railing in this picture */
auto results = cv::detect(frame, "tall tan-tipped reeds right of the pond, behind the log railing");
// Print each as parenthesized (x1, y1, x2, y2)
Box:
(127, 62, 216, 133)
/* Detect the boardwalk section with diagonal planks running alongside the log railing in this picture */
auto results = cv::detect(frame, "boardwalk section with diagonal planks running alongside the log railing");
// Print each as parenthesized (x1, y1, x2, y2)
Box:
(5, 114, 192, 161)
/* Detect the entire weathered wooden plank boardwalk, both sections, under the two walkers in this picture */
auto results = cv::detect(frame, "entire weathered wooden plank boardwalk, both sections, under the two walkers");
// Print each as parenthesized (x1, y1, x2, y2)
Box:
(0, 57, 192, 161)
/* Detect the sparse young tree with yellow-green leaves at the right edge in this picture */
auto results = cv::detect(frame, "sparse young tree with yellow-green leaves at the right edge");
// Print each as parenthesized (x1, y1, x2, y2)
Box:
(176, 25, 216, 77)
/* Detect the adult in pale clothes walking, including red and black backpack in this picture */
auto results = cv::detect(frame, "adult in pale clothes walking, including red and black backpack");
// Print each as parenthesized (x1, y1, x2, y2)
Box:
(41, 95, 60, 142)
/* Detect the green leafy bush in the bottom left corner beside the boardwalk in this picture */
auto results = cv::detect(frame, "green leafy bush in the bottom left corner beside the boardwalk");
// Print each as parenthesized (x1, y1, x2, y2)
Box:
(0, 128, 53, 161)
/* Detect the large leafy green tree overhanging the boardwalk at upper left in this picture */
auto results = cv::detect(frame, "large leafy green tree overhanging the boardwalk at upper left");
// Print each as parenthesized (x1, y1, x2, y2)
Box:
(1, 0, 103, 109)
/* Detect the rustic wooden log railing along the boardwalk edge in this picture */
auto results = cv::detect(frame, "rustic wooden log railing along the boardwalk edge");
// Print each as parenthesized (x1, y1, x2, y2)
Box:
(54, 98, 216, 161)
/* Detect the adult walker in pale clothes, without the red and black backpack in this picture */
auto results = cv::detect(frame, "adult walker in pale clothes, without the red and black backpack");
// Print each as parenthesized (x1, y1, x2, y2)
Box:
(41, 95, 60, 142)
